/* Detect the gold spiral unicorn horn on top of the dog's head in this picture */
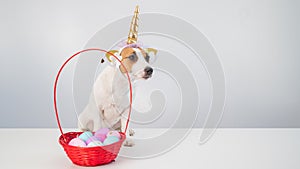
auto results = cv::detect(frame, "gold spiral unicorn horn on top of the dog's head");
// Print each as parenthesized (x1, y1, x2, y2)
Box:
(127, 5, 140, 44)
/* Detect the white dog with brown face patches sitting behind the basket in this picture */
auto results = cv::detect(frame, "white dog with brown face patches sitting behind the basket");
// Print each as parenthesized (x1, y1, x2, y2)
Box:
(78, 45, 157, 146)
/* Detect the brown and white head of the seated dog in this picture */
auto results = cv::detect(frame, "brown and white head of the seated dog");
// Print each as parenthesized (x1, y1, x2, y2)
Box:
(107, 46, 157, 79)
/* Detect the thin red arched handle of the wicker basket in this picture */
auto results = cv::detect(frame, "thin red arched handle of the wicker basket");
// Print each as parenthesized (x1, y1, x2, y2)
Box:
(53, 48, 132, 140)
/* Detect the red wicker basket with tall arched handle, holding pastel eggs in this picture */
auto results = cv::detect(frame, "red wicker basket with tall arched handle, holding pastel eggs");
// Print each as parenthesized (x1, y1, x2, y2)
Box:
(54, 48, 132, 166)
